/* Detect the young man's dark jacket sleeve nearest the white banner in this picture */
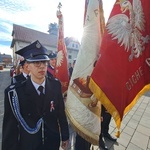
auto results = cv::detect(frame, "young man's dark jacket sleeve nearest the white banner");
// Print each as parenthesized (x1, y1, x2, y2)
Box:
(58, 81, 69, 141)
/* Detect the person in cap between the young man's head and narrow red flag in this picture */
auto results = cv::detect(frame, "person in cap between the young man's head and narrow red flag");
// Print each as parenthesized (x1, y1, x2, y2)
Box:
(47, 52, 57, 77)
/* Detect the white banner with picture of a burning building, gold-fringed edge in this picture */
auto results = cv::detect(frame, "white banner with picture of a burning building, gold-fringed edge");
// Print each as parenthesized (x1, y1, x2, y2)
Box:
(66, 0, 105, 145)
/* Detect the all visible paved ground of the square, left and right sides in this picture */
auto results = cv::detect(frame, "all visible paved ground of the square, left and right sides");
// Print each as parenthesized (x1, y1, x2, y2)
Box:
(0, 69, 150, 150)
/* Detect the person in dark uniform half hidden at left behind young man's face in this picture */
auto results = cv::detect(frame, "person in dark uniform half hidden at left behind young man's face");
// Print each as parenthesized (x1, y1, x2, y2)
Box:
(11, 58, 29, 84)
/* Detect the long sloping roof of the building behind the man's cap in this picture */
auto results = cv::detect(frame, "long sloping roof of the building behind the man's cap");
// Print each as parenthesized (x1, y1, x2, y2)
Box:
(11, 24, 57, 48)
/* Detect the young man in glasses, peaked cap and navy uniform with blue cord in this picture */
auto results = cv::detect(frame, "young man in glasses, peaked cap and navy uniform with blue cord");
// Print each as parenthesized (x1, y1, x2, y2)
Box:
(2, 41, 69, 150)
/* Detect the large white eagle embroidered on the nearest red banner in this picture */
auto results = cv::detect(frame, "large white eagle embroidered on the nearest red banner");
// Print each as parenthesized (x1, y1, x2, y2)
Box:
(106, 0, 150, 61)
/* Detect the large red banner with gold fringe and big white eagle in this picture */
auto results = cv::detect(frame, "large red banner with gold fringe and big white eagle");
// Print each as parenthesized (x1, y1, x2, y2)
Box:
(89, 0, 150, 136)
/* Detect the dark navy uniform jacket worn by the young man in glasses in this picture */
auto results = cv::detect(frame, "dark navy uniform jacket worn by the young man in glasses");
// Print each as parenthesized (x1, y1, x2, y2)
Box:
(2, 78, 69, 150)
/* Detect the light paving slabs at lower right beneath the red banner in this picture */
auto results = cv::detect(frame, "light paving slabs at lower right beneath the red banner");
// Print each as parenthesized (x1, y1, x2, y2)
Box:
(94, 92, 150, 150)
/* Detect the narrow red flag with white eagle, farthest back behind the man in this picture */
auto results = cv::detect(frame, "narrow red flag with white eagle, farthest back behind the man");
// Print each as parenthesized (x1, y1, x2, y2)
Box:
(55, 4, 69, 93)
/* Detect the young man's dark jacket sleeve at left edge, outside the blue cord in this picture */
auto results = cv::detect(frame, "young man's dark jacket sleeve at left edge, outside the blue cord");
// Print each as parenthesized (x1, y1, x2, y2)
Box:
(2, 90, 19, 150)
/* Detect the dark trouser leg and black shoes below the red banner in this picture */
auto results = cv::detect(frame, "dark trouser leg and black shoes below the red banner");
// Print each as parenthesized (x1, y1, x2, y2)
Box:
(99, 105, 117, 150)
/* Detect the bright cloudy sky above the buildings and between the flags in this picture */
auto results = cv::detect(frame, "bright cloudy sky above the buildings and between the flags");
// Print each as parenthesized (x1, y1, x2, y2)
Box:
(0, 0, 116, 55)
